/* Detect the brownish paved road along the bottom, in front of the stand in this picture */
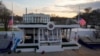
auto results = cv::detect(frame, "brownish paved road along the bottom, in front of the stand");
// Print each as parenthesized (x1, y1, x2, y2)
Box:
(0, 47, 100, 56)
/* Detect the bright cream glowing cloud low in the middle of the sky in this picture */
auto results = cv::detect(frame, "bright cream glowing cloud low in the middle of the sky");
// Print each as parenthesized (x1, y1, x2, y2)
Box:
(34, 6, 76, 17)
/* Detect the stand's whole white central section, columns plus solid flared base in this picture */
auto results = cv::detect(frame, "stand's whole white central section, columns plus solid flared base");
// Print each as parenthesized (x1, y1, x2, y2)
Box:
(37, 28, 63, 52)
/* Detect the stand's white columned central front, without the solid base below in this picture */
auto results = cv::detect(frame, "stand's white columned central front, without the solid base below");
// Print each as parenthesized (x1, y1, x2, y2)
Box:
(39, 28, 61, 46)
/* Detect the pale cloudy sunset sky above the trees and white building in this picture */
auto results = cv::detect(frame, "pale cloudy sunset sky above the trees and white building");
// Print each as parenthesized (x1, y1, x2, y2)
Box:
(2, 0, 100, 18)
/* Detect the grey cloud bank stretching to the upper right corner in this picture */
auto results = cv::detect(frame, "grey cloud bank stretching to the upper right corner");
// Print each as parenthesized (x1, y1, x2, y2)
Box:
(55, 0, 100, 13)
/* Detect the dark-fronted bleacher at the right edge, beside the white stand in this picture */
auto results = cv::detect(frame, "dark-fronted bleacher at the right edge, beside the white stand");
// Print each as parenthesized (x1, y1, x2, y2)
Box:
(78, 38, 100, 49)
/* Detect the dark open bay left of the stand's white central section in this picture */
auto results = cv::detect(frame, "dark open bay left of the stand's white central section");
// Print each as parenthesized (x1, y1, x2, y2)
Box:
(24, 28, 38, 44)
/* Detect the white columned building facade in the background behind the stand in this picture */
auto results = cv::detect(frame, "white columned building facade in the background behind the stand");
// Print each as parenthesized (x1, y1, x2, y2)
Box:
(23, 13, 50, 24)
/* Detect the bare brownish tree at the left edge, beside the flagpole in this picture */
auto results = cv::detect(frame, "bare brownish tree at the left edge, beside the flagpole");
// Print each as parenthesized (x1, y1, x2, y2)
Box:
(0, 1, 11, 31)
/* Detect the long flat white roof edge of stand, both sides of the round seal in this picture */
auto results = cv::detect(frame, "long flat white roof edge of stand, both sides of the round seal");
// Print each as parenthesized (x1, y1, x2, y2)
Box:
(16, 24, 80, 29)
